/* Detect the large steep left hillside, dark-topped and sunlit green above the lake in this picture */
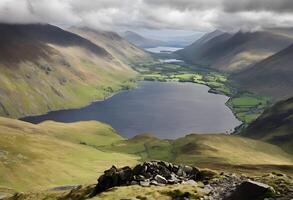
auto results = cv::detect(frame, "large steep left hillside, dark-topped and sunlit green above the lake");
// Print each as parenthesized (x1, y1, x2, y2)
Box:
(0, 24, 136, 117)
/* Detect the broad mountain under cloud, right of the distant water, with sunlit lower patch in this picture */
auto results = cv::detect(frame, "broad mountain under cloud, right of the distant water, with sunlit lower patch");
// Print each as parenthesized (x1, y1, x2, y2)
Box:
(176, 31, 293, 72)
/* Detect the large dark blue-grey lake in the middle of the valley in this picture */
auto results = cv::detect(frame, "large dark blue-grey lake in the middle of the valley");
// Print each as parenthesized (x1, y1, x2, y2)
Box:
(22, 81, 240, 139)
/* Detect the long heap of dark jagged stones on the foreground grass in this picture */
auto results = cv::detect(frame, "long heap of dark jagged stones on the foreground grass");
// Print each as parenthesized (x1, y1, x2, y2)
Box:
(92, 161, 200, 196)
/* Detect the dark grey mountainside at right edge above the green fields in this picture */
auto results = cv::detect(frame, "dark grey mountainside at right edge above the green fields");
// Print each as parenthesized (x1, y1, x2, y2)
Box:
(232, 44, 293, 100)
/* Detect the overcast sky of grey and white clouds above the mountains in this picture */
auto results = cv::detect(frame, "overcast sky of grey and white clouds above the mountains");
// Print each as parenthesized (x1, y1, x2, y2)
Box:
(0, 0, 293, 37)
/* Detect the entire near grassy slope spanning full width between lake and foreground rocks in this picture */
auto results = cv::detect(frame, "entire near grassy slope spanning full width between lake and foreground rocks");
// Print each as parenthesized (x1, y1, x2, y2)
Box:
(0, 118, 293, 190)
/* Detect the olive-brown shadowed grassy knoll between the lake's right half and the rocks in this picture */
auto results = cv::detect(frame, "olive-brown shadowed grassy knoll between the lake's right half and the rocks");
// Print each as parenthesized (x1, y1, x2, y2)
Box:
(101, 134, 293, 171)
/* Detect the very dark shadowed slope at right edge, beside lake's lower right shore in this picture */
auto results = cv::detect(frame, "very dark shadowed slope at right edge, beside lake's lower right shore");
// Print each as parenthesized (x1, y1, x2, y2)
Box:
(242, 97, 293, 153)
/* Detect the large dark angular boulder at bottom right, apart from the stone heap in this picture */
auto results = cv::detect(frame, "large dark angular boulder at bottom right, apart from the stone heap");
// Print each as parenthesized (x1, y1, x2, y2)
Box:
(225, 180, 274, 200)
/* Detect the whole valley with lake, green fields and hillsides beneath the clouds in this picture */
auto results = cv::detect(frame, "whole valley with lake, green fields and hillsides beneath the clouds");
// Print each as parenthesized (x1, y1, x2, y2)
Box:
(0, 21, 293, 200)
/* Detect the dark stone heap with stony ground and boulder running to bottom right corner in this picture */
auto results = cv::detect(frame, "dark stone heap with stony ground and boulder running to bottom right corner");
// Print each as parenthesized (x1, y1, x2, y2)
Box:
(86, 161, 293, 200)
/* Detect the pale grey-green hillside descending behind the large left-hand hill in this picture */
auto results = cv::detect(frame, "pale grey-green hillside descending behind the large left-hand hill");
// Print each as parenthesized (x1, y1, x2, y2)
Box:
(69, 27, 152, 64)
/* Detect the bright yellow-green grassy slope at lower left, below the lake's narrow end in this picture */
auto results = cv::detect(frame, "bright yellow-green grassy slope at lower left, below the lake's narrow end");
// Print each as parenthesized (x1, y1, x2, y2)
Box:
(0, 118, 137, 190)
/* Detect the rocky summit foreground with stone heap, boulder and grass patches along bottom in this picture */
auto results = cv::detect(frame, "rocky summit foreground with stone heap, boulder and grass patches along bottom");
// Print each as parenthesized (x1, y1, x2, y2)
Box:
(2, 161, 293, 200)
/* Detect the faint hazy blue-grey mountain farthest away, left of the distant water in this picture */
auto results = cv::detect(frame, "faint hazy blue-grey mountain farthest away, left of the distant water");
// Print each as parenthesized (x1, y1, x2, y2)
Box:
(122, 31, 168, 48)
